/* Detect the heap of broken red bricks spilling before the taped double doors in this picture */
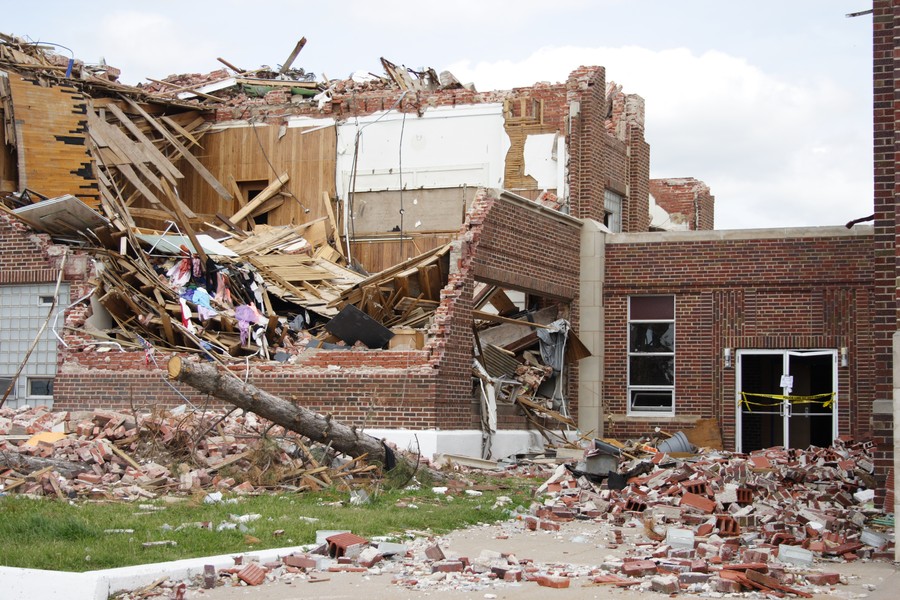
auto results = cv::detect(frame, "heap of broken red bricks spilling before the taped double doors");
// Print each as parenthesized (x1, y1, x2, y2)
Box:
(100, 440, 893, 598)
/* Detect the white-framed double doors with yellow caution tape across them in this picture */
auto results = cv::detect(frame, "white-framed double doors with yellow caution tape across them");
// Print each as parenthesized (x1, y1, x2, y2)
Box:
(735, 350, 838, 452)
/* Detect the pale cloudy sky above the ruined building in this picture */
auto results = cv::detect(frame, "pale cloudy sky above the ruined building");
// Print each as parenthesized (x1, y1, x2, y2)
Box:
(0, 0, 873, 229)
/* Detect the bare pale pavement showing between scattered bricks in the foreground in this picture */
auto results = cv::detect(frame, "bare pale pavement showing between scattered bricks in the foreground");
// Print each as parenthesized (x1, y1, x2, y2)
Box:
(186, 521, 900, 600)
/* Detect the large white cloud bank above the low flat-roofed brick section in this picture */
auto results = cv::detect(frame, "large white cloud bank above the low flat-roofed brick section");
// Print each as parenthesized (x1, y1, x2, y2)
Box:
(448, 47, 872, 229)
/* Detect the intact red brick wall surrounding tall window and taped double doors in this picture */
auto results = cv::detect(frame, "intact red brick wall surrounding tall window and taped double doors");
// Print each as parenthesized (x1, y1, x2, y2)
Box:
(603, 230, 874, 448)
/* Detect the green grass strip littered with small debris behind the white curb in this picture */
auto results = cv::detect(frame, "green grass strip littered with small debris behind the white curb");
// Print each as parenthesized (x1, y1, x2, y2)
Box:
(0, 478, 530, 571)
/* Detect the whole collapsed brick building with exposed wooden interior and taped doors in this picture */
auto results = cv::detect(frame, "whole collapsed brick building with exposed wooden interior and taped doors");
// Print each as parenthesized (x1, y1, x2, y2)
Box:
(0, 1, 896, 510)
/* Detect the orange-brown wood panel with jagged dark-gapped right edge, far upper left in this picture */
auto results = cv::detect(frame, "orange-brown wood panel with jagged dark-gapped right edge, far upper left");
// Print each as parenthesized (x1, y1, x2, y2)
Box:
(9, 74, 100, 208)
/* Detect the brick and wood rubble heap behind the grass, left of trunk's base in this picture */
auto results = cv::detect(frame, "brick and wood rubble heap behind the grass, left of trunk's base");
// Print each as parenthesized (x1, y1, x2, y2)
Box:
(0, 406, 378, 500)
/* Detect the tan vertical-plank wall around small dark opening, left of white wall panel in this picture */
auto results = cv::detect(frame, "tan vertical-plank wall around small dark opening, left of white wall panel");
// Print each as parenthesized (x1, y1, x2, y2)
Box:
(176, 124, 335, 230)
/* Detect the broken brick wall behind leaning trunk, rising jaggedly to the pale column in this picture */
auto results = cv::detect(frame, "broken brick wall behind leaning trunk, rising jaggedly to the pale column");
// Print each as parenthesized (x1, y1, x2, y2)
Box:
(54, 192, 580, 429)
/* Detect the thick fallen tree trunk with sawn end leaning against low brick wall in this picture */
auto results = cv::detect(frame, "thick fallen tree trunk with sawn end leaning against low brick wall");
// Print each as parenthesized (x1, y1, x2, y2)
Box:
(168, 356, 404, 470)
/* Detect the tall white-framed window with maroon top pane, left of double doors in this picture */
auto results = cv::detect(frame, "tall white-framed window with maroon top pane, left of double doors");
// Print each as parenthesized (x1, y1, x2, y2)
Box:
(628, 296, 675, 415)
